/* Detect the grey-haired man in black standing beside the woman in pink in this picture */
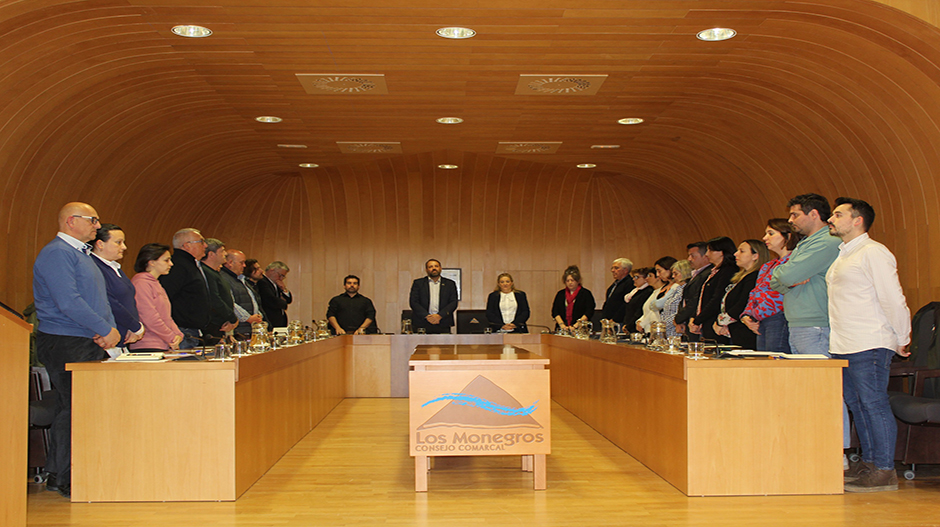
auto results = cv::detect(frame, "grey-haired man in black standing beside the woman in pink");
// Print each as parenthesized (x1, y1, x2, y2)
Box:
(160, 228, 209, 349)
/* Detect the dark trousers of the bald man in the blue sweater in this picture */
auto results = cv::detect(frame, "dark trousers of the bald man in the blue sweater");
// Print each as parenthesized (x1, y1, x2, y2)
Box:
(36, 331, 108, 487)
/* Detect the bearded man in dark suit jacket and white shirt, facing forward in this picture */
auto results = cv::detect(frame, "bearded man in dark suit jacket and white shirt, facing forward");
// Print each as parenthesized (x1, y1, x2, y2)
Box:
(409, 259, 457, 333)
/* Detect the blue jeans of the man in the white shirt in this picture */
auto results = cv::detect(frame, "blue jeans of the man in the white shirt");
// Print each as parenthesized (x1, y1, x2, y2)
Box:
(833, 348, 898, 470)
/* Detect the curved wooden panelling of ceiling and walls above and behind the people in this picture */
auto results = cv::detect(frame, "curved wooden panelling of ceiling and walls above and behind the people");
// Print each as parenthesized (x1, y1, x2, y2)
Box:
(0, 0, 940, 329)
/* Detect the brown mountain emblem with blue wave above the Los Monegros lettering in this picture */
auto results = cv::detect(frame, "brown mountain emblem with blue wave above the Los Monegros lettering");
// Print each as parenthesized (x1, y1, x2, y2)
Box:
(418, 375, 542, 430)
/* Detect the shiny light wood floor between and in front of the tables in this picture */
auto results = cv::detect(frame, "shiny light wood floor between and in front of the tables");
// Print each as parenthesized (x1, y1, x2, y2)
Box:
(27, 399, 940, 527)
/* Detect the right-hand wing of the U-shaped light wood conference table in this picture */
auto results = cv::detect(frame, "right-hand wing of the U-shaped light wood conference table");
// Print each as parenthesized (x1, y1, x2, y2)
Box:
(542, 335, 846, 496)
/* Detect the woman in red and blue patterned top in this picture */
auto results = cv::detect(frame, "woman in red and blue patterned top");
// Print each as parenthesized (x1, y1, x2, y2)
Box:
(741, 218, 802, 353)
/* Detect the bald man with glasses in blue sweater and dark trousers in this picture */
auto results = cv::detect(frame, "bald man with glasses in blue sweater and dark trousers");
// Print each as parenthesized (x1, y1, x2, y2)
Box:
(33, 202, 121, 497)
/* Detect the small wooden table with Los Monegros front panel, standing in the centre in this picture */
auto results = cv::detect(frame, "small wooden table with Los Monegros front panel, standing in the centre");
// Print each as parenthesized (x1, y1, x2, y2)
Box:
(408, 344, 551, 492)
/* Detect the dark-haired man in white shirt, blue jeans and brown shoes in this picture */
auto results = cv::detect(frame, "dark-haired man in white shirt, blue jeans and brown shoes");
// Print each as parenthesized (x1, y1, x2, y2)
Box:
(826, 198, 911, 492)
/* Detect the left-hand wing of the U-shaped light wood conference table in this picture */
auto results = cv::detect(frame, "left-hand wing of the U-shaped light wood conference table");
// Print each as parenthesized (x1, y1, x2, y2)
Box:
(68, 338, 346, 501)
